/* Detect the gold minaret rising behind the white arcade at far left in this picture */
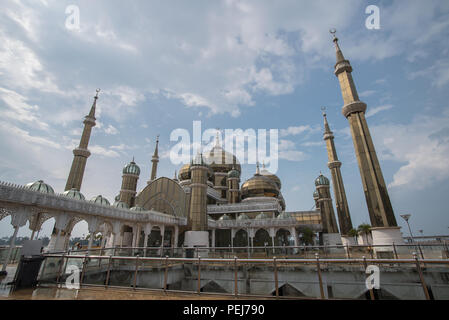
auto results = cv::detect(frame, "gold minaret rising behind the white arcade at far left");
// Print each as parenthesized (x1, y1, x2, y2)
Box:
(65, 89, 100, 191)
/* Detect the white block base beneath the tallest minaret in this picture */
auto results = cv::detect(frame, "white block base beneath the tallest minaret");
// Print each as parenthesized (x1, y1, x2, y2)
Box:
(371, 227, 405, 258)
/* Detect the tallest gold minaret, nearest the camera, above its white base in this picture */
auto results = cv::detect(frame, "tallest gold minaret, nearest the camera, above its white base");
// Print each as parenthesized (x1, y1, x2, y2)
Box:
(331, 30, 397, 230)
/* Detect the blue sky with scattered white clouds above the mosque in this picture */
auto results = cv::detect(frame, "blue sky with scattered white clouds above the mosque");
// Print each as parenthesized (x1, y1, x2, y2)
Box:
(0, 0, 449, 240)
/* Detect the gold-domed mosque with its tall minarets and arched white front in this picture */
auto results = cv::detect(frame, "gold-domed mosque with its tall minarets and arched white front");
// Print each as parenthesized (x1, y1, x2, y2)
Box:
(18, 31, 403, 252)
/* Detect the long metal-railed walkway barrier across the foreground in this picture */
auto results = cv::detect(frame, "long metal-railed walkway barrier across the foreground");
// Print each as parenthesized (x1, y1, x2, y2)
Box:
(38, 252, 449, 300)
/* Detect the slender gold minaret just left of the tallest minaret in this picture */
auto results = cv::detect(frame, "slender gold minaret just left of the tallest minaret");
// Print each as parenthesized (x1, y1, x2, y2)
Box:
(323, 109, 352, 236)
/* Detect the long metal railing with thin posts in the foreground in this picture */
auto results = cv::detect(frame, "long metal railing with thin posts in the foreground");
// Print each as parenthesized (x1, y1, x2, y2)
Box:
(39, 252, 449, 300)
